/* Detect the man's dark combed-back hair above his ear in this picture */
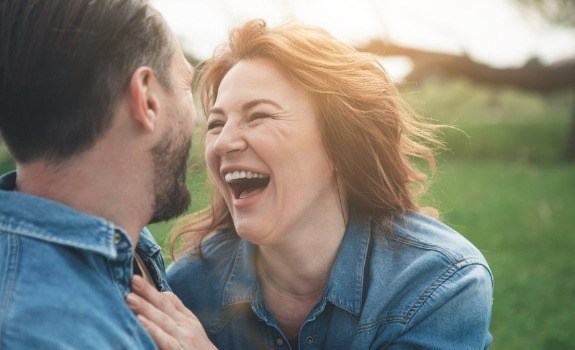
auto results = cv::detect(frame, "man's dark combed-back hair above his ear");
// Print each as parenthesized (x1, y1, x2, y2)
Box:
(0, 0, 174, 163)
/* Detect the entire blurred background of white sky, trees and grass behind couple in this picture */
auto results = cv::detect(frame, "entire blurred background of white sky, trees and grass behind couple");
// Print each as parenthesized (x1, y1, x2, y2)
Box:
(0, 0, 575, 349)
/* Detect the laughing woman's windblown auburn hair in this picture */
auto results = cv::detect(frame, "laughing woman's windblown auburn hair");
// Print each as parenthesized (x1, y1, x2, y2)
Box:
(171, 19, 441, 254)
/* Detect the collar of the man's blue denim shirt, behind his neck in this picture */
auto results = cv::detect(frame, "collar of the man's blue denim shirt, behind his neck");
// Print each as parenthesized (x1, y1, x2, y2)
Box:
(0, 172, 130, 259)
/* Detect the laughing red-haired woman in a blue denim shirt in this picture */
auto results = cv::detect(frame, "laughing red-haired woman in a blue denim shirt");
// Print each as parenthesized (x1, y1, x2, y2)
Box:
(128, 20, 493, 349)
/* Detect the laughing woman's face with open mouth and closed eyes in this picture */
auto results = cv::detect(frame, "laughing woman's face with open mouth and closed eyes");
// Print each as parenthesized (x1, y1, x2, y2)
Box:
(205, 59, 341, 244)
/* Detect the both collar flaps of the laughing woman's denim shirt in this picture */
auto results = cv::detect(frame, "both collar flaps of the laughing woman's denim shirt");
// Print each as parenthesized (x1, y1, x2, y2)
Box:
(222, 216, 371, 315)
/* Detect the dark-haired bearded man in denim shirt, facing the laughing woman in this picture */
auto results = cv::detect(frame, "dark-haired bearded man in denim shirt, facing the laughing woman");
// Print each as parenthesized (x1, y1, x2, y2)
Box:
(0, 0, 200, 349)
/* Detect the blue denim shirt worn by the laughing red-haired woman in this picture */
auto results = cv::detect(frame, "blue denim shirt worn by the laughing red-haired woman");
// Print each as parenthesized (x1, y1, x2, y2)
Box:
(168, 213, 493, 350)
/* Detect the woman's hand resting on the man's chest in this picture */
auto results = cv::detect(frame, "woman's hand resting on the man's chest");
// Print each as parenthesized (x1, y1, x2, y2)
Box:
(126, 275, 216, 350)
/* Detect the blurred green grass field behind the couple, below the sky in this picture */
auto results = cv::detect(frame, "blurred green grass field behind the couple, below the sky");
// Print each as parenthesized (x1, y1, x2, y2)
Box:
(0, 81, 575, 350)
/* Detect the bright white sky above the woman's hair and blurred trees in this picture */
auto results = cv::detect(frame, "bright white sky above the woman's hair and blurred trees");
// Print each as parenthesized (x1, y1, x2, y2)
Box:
(152, 0, 575, 75)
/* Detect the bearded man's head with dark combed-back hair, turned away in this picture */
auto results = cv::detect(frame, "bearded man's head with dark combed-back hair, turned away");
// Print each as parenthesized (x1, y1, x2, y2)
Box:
(0, 0, 195, 222)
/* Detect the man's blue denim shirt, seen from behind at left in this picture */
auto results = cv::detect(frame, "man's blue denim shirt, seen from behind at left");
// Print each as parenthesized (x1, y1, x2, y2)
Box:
(0, 173, 169, 349)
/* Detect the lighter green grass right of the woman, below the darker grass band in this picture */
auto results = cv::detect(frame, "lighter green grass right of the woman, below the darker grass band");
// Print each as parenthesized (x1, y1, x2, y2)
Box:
(431, 159, 575, 349)
